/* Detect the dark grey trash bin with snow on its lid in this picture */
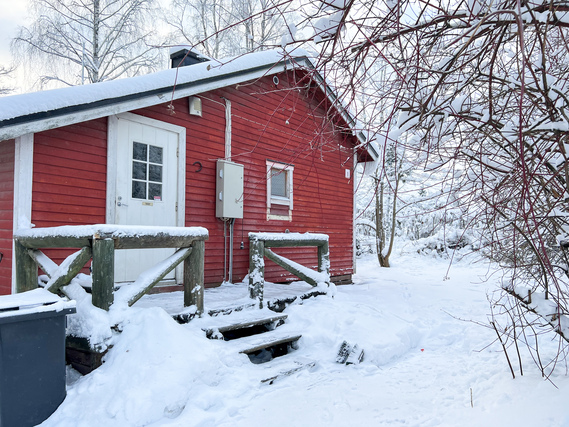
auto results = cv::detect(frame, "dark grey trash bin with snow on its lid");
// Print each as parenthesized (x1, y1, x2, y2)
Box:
(0, 289, 75, 427)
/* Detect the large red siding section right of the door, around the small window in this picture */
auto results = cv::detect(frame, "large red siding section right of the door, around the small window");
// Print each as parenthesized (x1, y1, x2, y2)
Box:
(135, 74, 353, 284)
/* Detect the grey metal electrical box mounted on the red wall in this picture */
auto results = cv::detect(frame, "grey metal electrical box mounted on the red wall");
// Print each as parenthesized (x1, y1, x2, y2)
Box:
(215, 159, 244, 218)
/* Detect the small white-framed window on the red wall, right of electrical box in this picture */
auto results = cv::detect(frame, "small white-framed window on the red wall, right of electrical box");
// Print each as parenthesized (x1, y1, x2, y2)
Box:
(267, 160, 294, 221)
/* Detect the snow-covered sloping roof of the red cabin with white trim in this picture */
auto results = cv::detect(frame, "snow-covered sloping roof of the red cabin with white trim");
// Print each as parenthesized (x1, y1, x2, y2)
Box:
(0, 49, 373, 160)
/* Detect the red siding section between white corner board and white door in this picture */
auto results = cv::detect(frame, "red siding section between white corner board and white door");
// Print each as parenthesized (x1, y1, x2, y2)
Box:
(32, 118, 107, 268)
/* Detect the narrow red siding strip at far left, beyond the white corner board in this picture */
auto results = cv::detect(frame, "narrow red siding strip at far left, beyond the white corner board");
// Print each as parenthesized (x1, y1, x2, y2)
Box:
(0, 140, 15, 295)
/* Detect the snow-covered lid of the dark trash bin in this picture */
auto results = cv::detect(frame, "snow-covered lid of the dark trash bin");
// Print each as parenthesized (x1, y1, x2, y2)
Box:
(0, 288, 75, 319)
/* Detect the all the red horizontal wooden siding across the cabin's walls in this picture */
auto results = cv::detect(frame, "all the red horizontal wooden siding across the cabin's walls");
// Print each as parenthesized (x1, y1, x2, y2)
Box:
(13, 69, 354, 285)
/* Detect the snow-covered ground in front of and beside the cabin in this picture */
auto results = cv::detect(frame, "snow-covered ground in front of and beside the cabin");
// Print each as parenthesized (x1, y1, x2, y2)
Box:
(43, 255, 569, 427)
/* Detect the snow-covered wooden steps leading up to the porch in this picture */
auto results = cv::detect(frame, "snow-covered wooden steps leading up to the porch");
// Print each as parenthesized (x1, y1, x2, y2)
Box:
(203, 311, 315, 384)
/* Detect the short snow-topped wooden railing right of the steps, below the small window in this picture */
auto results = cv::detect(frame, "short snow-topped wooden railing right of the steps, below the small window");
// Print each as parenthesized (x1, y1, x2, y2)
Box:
(249, 233, 330, 308)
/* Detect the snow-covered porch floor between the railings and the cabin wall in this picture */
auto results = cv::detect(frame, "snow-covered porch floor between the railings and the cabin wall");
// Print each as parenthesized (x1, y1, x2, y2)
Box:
(134, 282, 319, 316)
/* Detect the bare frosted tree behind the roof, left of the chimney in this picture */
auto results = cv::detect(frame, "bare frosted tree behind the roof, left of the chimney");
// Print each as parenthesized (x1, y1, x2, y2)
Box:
(12, 0, 162, 85)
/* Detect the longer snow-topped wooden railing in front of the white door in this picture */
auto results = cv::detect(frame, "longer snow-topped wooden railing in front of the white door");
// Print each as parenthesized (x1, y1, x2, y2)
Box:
(14, 224, 208, 315)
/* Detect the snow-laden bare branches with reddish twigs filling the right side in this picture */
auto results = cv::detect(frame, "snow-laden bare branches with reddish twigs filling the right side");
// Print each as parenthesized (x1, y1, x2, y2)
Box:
(254, 0, 569, 372)
